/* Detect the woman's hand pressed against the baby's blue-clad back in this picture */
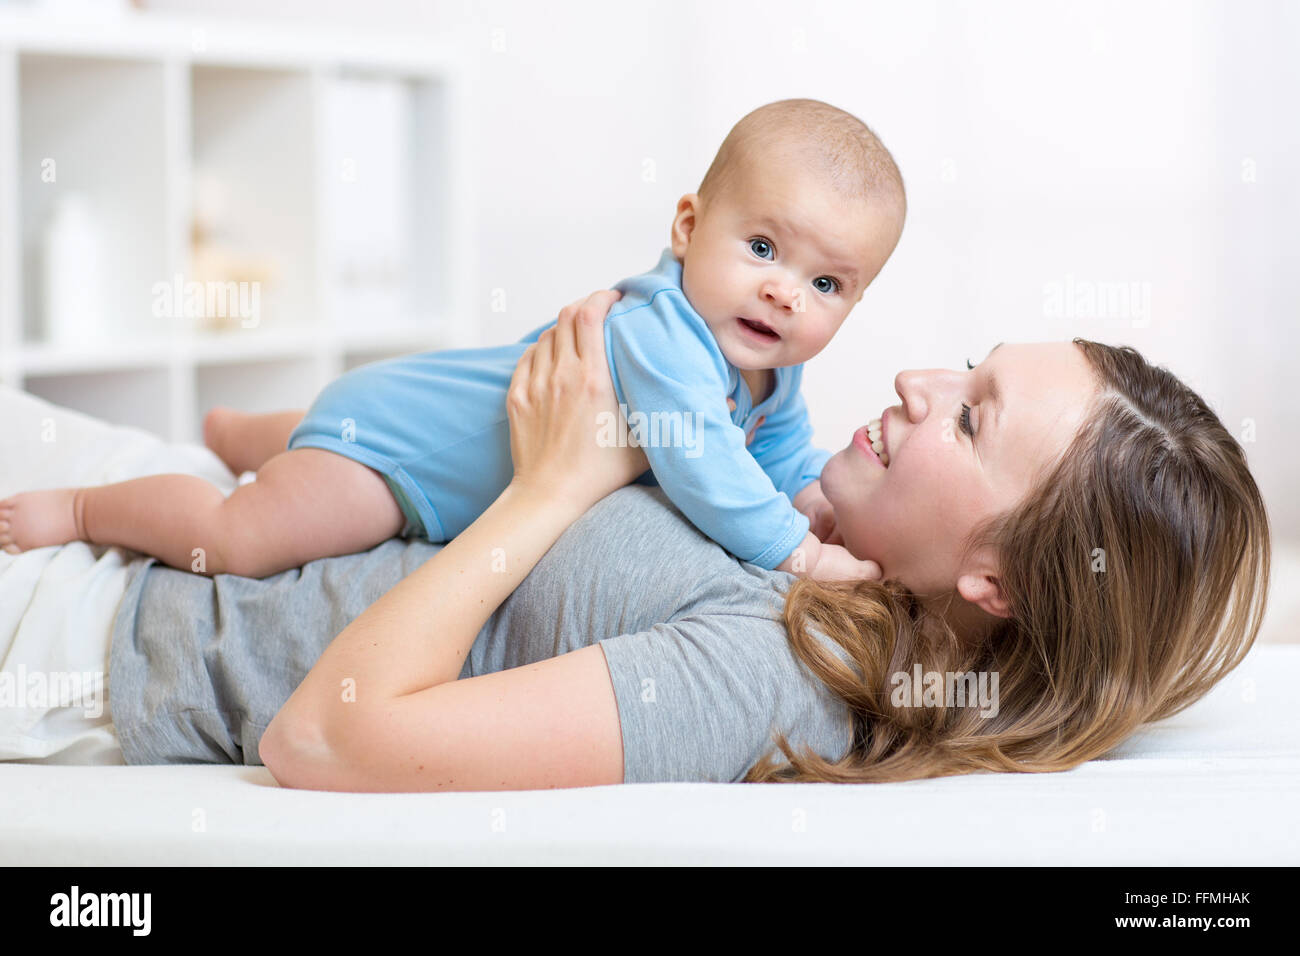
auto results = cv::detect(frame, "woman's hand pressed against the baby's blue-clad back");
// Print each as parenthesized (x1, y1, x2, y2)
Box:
(506, 290, 649, 511)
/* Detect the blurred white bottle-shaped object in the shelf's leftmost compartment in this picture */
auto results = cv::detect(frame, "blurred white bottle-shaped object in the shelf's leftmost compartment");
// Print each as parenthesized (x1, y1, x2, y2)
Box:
(40, 193, 105, 345)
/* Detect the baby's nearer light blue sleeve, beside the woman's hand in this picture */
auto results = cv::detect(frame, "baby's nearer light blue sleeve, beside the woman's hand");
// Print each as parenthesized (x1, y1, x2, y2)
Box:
(605, 289, 809, 570)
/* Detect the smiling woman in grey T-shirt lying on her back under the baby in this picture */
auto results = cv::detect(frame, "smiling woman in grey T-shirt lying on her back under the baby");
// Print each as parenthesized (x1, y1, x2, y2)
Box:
(112, 293, 1269, 791)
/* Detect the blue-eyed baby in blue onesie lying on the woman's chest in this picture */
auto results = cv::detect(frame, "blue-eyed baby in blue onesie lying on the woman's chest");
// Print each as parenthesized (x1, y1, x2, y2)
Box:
(0, 100, 906, 580)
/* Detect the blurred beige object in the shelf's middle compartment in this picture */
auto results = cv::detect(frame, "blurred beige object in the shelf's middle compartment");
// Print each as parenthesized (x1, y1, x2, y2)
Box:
(189, 169, 278, 332)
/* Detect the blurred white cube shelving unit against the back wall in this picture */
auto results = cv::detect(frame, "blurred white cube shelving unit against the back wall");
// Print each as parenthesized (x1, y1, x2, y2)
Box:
(0, 13, 477, 441)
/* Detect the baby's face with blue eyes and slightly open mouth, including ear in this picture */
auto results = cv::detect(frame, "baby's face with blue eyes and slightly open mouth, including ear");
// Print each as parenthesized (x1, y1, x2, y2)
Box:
(672, 164, 901, 369)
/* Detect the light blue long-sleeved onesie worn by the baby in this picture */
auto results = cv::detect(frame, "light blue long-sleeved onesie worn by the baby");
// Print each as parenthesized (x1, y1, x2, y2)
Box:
(289, 248, 831, 570)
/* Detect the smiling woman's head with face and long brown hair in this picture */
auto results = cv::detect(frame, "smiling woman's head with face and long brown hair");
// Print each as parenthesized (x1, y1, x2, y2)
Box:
(780, 339, 1269, 780)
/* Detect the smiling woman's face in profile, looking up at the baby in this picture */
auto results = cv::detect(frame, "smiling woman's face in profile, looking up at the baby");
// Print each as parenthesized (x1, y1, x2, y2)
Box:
(822, 342, 1096, 600)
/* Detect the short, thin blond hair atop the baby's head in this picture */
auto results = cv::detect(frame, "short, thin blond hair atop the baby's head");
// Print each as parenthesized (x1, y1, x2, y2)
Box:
(698, 99, 907, 216)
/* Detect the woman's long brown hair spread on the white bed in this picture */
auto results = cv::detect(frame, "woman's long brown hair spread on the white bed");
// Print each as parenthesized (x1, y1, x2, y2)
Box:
(745, 338, 1269, 783)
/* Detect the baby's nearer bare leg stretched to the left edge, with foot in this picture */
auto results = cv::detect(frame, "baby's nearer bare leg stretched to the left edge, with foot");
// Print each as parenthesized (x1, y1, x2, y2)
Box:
(0, 449, 406, 578)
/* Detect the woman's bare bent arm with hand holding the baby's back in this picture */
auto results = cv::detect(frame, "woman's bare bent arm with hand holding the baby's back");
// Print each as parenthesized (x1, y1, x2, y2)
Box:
(259, 293, 646, 791)
